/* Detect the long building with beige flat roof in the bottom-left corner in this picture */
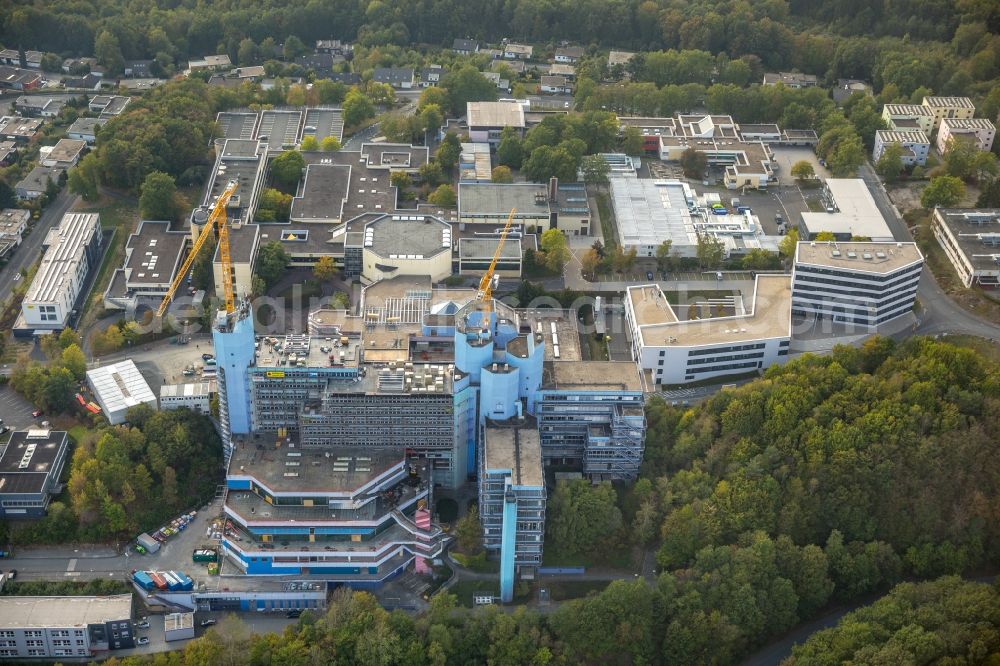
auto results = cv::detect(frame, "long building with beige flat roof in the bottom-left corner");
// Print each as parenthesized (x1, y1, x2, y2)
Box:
(0, 594, 135, 661)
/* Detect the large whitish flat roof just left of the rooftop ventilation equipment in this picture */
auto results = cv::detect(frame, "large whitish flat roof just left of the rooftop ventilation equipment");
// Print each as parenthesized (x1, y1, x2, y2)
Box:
(611, 178, 698, 247)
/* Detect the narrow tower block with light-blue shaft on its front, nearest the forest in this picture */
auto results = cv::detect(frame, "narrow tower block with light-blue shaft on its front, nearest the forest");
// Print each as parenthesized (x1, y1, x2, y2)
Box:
(479, 419, 545, 603)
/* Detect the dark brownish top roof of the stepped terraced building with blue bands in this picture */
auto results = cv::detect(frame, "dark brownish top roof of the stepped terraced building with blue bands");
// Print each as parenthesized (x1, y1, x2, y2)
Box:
(229, 437, 406, 495)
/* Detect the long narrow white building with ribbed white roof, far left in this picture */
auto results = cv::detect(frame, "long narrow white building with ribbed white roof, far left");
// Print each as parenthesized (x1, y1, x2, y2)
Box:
(18, 213, 101, 331)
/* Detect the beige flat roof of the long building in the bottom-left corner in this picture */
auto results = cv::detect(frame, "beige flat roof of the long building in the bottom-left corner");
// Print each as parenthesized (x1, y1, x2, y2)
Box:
(0, 594, 132, 629)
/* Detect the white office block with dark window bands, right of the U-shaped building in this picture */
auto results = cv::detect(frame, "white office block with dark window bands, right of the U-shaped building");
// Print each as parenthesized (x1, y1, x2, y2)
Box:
(792, 242, 924, 327)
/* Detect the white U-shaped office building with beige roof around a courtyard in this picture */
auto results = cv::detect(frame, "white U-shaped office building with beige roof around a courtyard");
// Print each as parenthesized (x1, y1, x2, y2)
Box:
(625, 275, 792, 384)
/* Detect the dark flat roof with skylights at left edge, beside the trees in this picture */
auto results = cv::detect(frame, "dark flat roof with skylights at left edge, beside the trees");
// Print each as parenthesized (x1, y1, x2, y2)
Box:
(0, 428, 67, 495)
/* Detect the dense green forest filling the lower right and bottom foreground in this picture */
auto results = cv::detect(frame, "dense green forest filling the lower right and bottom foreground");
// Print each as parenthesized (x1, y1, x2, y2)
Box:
(92, 339, 1000, 665)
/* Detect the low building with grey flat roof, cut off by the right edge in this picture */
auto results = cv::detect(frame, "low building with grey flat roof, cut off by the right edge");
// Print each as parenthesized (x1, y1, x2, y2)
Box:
(931, 208, 1000, 288)
